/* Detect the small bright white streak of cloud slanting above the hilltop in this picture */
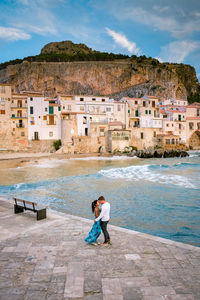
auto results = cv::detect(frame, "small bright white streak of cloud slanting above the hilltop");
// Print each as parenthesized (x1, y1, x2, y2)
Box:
(106, 28, 140, 55)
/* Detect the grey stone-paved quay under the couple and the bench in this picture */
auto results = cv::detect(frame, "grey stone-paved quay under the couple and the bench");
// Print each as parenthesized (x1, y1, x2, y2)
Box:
(0, 199, 200, 300)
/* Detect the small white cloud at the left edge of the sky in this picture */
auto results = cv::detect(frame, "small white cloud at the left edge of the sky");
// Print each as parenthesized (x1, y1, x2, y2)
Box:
(0, 27, 31, 41)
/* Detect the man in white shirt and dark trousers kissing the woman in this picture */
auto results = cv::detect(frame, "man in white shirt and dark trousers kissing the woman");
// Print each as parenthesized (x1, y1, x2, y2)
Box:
(94, 196, 111, 246)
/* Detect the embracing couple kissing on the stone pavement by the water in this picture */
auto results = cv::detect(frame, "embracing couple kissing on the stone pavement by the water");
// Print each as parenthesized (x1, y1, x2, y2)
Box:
(85, 196, 111, 246)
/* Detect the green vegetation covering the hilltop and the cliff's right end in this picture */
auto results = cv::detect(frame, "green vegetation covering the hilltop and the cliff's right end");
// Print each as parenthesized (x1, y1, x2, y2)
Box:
(0, 41, 200, 103)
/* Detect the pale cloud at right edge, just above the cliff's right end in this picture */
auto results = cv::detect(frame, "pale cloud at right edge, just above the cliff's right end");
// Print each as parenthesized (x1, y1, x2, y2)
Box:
(160, 40, 200, 63)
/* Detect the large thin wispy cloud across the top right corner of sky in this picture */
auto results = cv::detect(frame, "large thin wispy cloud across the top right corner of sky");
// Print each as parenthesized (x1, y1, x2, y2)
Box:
(92, 0, 200, 39)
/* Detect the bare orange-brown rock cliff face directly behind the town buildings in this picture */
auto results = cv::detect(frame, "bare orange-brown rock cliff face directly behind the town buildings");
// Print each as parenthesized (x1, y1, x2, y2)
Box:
(0, 60, 199, 99)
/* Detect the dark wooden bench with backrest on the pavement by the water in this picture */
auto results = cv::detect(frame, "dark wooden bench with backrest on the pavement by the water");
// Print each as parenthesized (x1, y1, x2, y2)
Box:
(13, 198, 46, 220)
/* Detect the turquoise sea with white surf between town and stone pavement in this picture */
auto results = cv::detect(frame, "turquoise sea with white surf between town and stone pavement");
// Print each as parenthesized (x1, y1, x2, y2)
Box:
(0, 152, 200, 246)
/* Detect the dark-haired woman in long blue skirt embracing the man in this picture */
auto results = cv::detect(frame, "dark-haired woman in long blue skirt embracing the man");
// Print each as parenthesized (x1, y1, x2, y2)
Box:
(85, 200, 101, 246)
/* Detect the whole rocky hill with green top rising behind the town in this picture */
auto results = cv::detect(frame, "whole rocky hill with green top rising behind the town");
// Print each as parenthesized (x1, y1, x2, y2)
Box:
(0, 41, 200, 101)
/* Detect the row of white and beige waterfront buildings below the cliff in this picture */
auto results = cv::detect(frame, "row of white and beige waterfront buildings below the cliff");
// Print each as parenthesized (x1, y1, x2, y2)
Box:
(0, 84, 200, 153)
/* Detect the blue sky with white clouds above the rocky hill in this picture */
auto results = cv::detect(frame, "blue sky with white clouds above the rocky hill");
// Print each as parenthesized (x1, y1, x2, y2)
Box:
(0, 0, 200, 80)
